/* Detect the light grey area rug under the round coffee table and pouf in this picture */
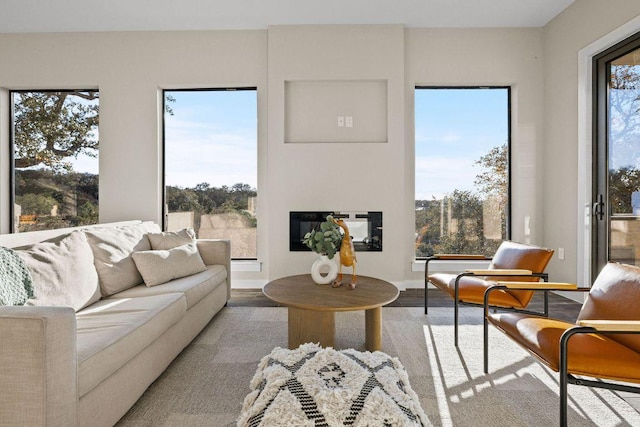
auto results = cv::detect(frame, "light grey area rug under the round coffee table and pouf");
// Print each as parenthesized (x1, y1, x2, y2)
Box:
(118, 307, 640, 427)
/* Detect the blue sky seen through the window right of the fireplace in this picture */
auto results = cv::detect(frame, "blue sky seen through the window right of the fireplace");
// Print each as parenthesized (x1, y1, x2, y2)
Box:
(415, 89, 508, 200)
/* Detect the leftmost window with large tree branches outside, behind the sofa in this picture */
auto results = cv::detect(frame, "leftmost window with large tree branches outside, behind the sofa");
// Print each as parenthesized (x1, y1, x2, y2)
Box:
(11, 90, 99, 232)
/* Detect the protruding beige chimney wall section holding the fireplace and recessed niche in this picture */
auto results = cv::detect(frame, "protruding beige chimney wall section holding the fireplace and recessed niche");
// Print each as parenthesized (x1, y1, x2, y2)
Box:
(267, 25, 410, 283)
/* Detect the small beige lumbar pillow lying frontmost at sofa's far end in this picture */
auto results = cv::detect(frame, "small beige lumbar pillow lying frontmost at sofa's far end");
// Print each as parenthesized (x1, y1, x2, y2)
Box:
(133, 243, 207, 286)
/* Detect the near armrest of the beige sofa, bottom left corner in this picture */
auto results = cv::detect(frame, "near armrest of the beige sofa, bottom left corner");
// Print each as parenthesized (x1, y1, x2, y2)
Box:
(0, 307, 78, 426)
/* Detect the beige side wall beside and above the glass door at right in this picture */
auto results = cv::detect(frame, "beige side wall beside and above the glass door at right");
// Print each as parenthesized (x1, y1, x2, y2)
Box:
(540, 0, 640, 288)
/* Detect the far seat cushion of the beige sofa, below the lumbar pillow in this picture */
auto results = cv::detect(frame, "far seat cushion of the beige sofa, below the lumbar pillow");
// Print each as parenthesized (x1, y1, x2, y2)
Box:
(110, 265, 228, 309)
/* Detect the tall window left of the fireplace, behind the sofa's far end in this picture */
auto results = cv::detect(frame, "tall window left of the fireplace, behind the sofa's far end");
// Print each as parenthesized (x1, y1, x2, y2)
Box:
(164, 88, 258, 259)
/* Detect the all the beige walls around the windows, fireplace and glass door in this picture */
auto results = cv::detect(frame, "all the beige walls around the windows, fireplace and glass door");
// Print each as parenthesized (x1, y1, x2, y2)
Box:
(0, 4, 640, 286)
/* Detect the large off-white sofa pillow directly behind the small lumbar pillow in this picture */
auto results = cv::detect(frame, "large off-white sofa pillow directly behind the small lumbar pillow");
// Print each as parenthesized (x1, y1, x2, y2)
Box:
(85, 222, 160, 296)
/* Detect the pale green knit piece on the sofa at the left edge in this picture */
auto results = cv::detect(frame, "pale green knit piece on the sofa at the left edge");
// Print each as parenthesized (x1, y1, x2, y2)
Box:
(0, 246, 33, 305)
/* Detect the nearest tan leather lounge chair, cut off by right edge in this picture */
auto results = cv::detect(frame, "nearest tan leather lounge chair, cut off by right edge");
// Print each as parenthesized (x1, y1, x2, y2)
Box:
(484, 263, 640, 426)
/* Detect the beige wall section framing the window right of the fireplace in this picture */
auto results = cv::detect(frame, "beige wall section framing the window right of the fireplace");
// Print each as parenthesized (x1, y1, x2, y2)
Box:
(404, 29, 544, 288)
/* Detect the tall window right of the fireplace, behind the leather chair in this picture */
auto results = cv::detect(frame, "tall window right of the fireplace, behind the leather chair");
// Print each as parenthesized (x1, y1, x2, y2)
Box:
(415, 87, 510, 258)
